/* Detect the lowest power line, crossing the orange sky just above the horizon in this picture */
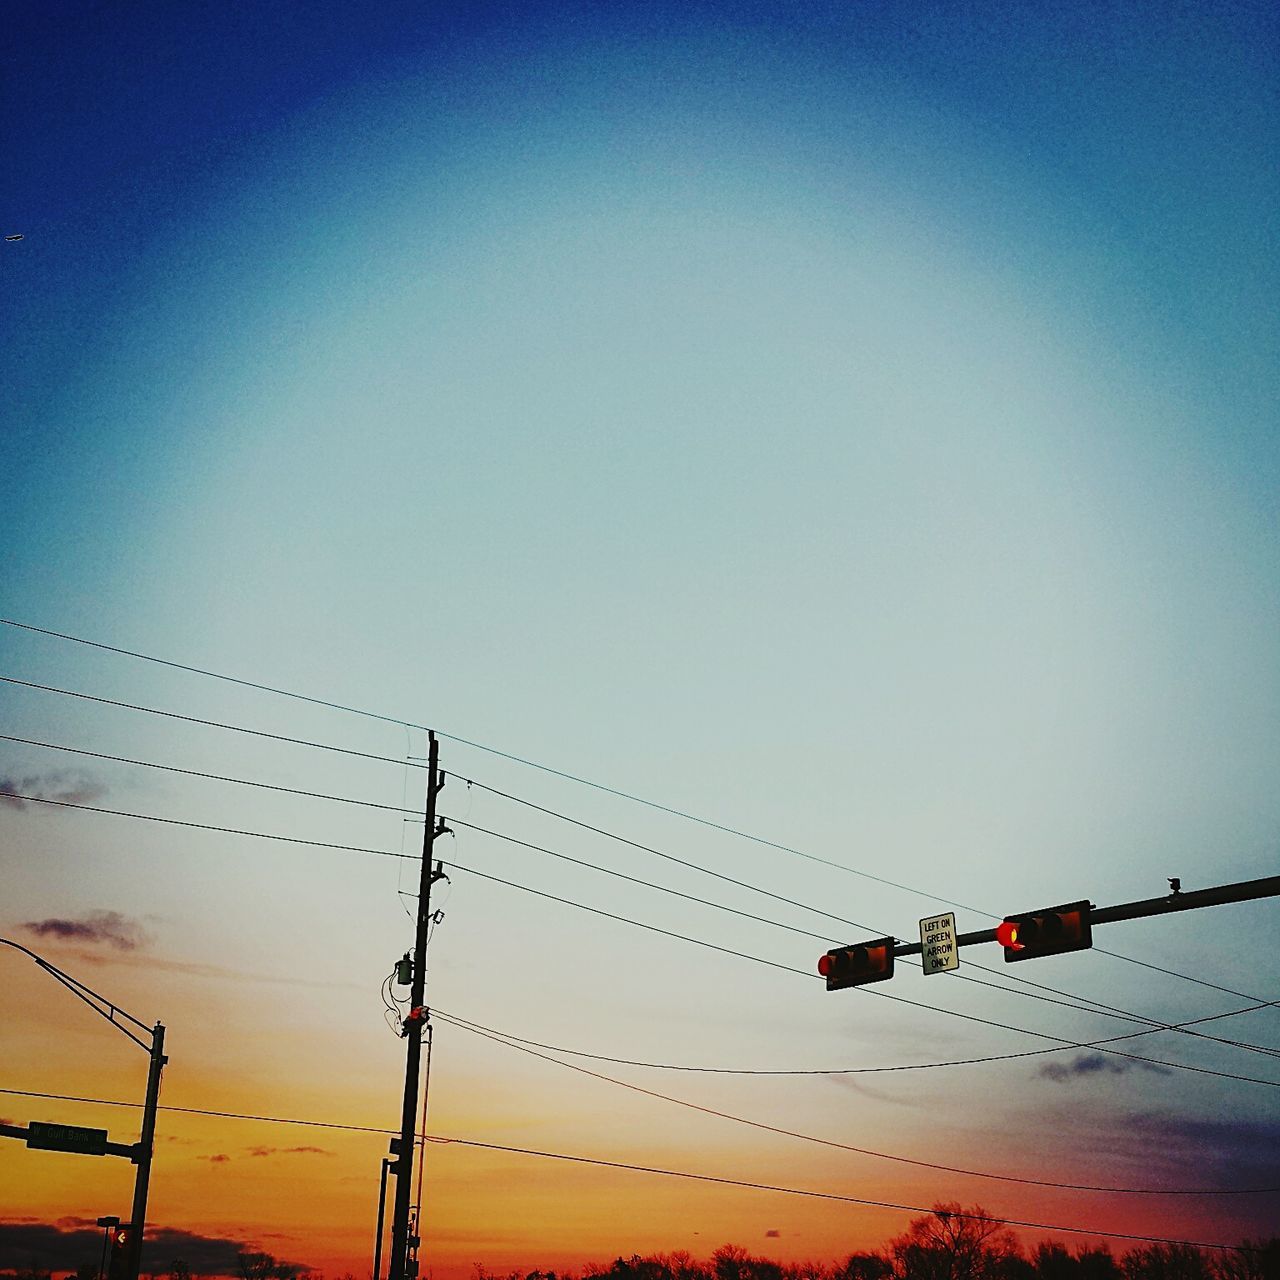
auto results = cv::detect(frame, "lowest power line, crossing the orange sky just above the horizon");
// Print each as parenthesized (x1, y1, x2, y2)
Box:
(0, 1088, 1251, 1253)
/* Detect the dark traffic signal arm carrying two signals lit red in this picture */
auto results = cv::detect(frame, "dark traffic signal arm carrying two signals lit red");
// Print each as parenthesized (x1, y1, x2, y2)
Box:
(818, 876, 1280, 991)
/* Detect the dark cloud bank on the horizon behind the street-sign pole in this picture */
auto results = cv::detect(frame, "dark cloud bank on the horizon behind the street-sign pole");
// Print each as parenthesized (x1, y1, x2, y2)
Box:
(0, 1219, 310, 1276)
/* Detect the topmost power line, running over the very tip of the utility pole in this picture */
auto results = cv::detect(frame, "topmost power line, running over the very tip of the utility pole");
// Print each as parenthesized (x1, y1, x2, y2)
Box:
(0, 618, 1258, 1000)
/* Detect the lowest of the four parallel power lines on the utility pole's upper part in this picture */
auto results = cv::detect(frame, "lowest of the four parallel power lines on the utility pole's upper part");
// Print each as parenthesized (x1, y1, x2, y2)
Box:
(9, 792, 1280, 1088)
